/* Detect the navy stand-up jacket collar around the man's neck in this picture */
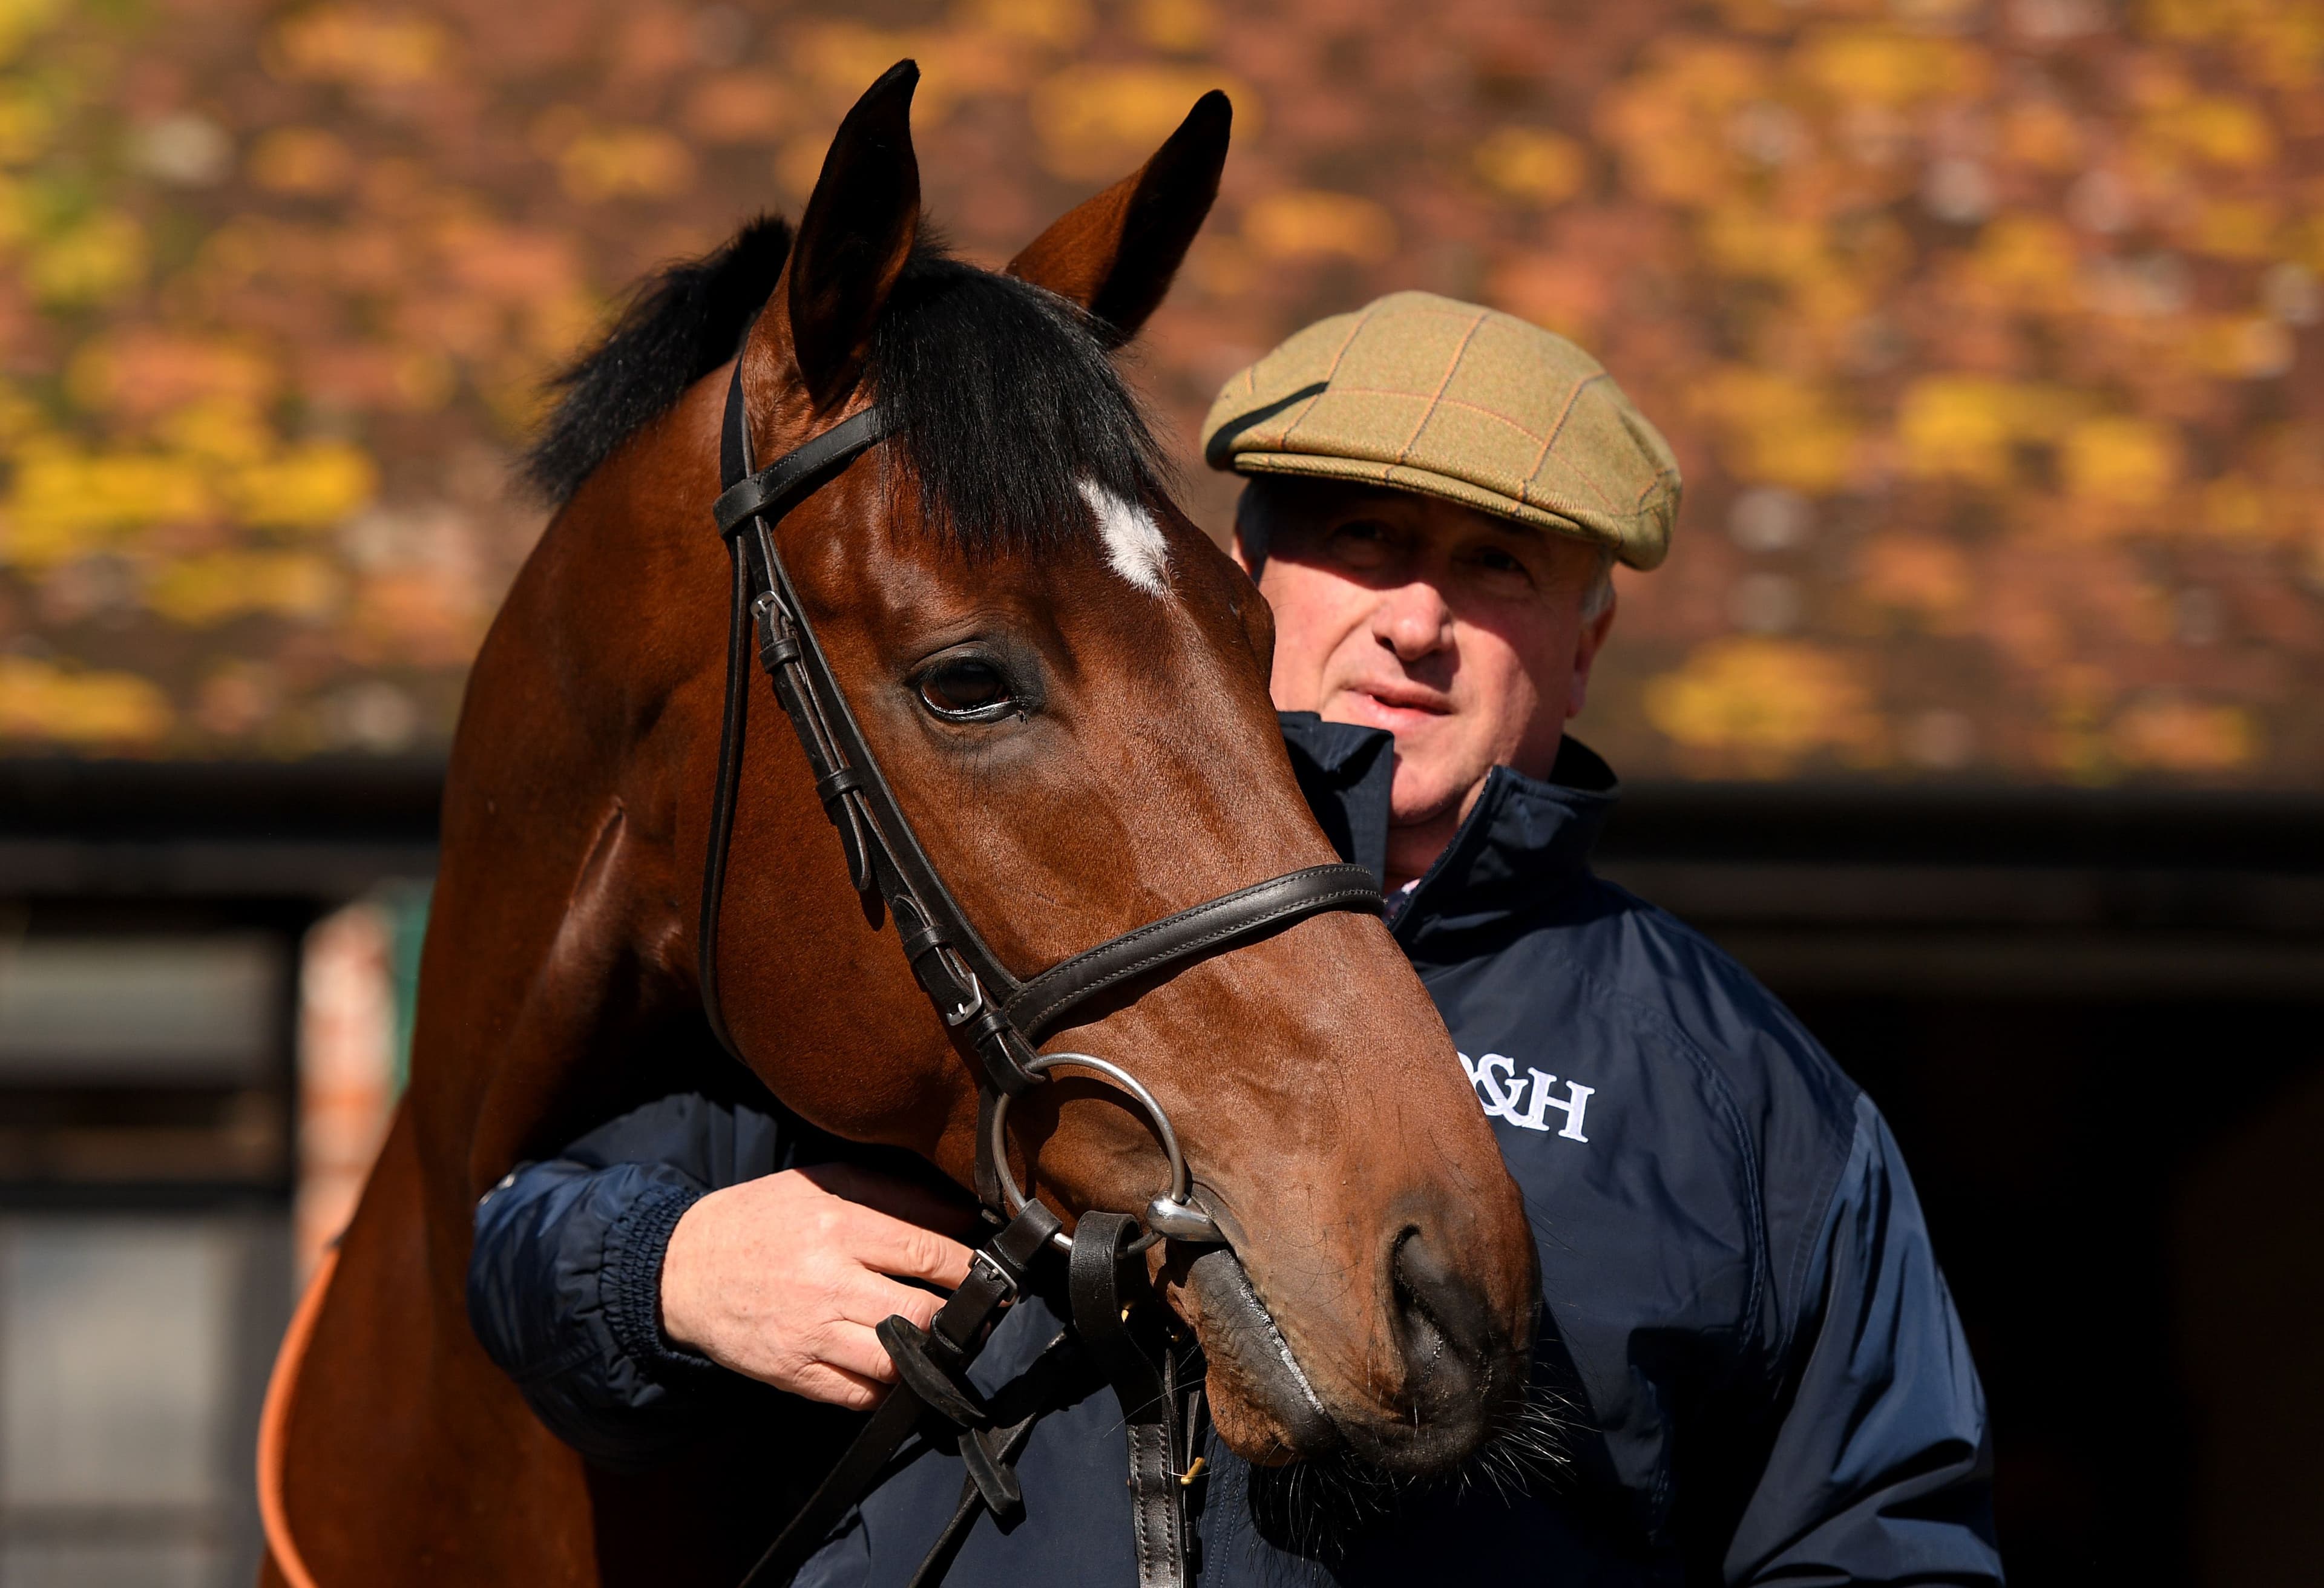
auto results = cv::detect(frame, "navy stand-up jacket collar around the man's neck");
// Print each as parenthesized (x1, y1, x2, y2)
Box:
(1283, 712, 1620, 960)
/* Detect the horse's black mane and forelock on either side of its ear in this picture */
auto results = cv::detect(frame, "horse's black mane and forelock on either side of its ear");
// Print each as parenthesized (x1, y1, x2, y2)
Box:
(525, 218, 1164, 553)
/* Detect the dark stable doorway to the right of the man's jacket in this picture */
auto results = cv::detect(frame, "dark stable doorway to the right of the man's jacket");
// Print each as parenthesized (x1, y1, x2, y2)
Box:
(1778, 988, 2324, 1588)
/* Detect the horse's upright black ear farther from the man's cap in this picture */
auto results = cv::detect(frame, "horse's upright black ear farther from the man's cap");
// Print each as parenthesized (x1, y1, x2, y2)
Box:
(790, 61, 921, 409)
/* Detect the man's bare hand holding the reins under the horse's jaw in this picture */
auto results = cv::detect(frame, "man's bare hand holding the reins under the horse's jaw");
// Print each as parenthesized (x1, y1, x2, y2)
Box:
(662, 1165, 974, 1411)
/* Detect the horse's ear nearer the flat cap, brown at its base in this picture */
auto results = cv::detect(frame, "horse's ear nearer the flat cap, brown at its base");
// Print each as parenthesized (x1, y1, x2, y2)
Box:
(1009, 88, 1234, 344)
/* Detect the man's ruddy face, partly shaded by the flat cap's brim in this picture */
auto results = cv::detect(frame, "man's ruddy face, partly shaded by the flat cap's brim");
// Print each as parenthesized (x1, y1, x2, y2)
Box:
(1246, 479, 1613, 881)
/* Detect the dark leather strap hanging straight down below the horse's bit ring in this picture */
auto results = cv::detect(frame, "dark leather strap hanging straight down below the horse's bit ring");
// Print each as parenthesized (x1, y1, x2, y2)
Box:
(1067, 1212, 1187, 1588)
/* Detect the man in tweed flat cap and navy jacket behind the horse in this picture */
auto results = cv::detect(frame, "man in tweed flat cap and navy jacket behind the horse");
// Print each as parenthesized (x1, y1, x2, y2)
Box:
(472, 293, 2001, 1588)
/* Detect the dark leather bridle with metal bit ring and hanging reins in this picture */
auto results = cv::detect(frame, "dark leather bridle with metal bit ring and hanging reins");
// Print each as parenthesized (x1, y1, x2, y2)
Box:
(700, 358, 1380, 1588)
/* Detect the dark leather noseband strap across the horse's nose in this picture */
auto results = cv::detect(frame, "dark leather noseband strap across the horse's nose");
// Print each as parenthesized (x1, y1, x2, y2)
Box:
(1006, 865, 1380, 1042)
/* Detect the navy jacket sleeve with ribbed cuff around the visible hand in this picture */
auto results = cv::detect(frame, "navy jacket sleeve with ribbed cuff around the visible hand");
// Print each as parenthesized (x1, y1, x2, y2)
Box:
(467, 1093, 790, 1467)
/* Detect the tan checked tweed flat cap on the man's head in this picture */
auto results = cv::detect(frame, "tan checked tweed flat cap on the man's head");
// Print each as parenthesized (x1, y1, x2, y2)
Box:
(1201, 293, 1678, 567)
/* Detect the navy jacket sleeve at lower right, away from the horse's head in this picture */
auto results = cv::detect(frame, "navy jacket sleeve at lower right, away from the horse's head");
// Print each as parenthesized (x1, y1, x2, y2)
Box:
(1724, 1097, 2001, 1586)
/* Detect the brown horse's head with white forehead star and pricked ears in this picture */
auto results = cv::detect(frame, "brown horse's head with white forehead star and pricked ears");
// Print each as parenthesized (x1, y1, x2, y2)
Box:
(678, 65, 1538, 1472)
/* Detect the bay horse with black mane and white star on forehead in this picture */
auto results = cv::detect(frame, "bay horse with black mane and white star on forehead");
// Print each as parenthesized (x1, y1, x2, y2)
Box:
(260, 63, 1538, 1588)
